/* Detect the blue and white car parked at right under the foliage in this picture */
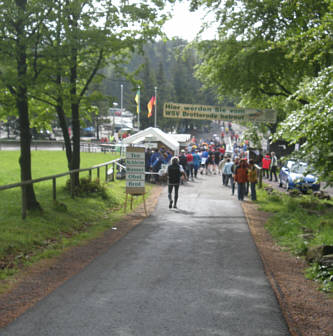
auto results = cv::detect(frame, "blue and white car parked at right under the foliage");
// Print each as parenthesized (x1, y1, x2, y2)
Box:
(279, 160, 320, 191)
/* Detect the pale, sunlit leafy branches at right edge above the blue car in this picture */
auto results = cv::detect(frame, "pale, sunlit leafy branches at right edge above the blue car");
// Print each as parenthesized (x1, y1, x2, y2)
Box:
(275, 66, 333, 184)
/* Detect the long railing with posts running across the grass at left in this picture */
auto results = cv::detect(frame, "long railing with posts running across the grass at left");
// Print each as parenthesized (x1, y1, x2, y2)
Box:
(0, 158, 123, 219)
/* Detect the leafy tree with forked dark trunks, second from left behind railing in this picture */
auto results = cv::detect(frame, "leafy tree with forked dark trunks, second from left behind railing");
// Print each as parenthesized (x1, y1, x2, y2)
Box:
(16, 0, 170, 185)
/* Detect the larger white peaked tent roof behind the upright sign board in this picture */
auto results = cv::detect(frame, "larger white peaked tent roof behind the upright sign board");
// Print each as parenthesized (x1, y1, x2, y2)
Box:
(122, 127, 179, 155)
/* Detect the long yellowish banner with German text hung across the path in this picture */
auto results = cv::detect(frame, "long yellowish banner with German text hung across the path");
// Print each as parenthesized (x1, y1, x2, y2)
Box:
(163, 103, 276, 123)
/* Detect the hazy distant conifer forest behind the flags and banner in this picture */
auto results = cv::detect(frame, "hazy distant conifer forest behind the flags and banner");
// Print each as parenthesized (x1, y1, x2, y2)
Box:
(99, 39, 217, 132)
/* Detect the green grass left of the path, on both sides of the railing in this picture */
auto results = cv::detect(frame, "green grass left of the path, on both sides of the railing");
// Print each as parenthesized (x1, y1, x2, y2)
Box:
(0, 151, 150, 292)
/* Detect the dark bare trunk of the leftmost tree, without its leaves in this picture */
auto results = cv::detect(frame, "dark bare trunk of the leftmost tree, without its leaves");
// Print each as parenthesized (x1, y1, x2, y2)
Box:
(15, 0, 41, 211)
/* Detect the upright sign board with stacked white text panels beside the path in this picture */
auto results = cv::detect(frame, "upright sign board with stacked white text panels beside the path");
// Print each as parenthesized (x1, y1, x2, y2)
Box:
(126, 146, 145, 195)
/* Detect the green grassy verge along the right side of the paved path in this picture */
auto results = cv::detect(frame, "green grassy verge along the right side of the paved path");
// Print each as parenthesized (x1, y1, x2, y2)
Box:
(258, 185, 333, 293)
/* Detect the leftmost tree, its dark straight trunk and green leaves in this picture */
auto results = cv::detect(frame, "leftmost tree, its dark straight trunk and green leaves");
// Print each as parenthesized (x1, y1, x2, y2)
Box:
(0, 0, 52, 210)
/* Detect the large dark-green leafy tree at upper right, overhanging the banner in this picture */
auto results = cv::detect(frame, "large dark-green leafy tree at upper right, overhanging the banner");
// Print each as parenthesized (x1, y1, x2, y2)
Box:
(192, 0, 331, 124)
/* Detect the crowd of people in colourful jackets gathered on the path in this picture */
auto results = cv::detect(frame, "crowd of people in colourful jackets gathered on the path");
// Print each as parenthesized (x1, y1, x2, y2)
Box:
(146, 133, 278, 208)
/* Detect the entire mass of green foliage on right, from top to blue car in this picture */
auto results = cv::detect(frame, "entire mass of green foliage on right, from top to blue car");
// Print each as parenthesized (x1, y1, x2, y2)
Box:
(192, 0, 333, 183)
